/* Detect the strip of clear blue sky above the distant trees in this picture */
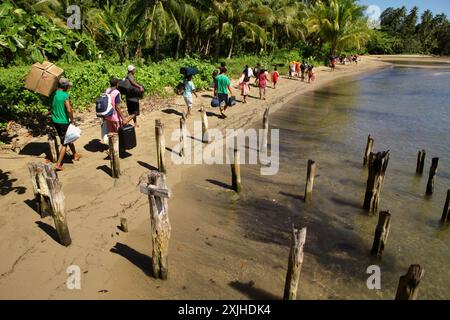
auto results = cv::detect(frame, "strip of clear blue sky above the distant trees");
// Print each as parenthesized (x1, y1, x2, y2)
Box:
(359, 0, 450, 18)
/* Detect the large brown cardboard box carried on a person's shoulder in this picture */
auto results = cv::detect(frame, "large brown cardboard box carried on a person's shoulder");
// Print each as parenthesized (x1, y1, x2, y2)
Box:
(25, 61, 64, 97)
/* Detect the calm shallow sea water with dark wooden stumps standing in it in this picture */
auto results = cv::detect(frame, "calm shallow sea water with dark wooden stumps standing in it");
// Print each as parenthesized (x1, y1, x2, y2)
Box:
(174, 67, 450, 299)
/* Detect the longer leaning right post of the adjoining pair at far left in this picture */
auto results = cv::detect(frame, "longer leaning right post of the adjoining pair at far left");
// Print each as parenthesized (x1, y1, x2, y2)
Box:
(44, 164, 72, 247)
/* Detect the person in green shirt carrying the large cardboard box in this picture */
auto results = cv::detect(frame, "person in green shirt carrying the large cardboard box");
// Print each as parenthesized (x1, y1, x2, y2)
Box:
(50, 78, 81, 171)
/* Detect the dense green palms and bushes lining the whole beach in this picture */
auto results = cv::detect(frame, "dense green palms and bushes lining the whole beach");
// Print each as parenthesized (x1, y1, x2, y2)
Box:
(0, 0, 450, 129)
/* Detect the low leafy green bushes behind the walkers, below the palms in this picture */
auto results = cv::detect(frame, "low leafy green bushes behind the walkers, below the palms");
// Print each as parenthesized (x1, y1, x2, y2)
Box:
(0, 58, 218, 123)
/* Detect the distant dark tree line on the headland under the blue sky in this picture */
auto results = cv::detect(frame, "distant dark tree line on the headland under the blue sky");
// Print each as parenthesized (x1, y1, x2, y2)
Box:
(367, 7, 450, 55)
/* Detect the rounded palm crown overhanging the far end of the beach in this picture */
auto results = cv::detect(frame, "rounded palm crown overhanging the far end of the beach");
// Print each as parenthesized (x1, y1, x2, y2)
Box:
(306, 0, 371, 56)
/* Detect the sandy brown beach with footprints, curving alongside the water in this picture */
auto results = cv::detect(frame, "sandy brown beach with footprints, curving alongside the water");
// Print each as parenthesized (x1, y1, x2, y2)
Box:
(0, 56, 391, 299)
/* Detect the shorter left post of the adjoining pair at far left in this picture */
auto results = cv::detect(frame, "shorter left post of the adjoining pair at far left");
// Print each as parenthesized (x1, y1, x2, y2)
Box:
(28, 163, 51, 218)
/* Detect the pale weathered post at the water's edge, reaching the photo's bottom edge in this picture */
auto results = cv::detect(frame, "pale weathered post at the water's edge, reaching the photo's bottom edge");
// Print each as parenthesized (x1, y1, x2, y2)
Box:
(283, 227, 306, 300)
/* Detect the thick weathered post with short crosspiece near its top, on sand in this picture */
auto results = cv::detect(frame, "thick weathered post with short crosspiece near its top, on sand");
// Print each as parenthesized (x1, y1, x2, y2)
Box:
(140, 170, 171, 280)
